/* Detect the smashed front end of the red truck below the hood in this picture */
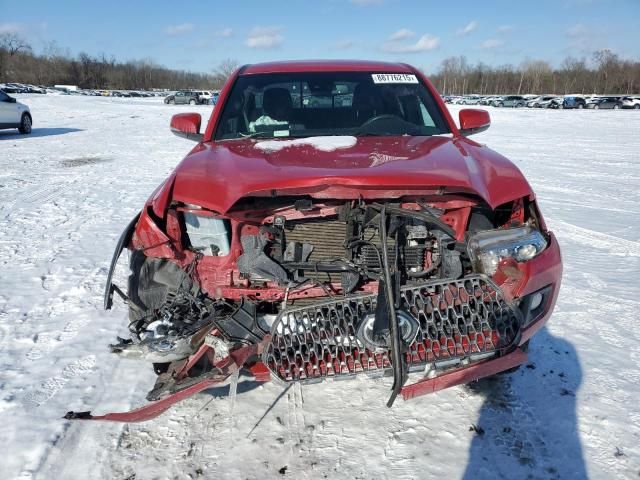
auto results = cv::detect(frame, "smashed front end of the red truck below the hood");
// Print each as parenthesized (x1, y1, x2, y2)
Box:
(67, 194, 559, 421)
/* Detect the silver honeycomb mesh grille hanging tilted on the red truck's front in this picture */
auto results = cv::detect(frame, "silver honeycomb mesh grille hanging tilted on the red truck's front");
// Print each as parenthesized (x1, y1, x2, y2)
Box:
(263, 275, 522, 381)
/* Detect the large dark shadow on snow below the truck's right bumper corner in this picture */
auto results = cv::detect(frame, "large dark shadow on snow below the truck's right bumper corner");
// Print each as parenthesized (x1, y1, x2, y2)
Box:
(463, 328, 587, 480)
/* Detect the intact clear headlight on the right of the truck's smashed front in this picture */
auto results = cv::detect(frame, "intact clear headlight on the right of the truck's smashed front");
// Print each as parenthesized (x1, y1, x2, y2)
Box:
(467, 226, 547, 275)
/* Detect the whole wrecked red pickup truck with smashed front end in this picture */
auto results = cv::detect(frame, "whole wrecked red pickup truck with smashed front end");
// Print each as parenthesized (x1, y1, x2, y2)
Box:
(67, 61, 562, 421)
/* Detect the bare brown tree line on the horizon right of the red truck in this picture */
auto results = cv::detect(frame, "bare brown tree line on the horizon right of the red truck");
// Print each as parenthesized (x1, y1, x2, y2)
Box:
(430, 50, 640, 95)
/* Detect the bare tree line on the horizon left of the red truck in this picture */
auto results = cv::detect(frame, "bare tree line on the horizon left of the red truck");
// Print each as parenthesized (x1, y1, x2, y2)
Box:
(0, 33, 237, 90)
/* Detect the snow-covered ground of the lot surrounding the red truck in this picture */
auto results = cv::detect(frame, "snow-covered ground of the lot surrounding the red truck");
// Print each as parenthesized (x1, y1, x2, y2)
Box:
(0, 96, 640, 479)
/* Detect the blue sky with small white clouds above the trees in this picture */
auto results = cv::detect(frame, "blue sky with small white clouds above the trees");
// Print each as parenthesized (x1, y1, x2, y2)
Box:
(0, 0, 640, 72)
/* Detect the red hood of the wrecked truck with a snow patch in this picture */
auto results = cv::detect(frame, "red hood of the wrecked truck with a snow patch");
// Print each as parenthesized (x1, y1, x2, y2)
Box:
(172, 136, 532, 213)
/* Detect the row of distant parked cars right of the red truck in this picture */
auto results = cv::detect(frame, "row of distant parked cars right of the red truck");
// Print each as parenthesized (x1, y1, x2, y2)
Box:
(443, 95, 640, 110)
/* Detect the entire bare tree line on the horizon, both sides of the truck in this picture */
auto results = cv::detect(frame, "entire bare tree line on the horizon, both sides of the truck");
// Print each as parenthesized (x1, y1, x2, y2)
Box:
(0, 33, 640, 95)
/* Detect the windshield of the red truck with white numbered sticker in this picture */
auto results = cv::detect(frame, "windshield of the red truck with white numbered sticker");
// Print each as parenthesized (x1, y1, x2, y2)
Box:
(215, 72, 450, 140)
